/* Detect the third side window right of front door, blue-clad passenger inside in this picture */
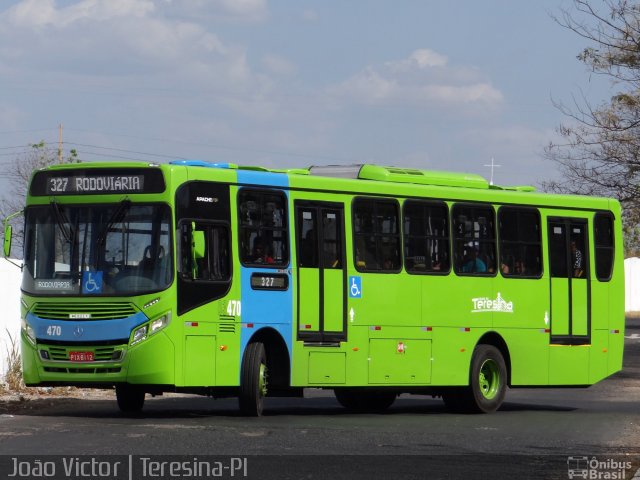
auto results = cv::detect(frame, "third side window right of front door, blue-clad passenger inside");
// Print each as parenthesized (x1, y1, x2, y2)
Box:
(452, 204, 496, 275)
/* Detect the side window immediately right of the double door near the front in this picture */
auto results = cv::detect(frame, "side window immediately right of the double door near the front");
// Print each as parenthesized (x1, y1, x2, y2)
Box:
(353, 198, 402, 272)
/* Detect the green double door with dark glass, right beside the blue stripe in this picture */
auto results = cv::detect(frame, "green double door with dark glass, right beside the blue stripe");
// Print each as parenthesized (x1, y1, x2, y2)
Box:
(295, 201, 347, 344)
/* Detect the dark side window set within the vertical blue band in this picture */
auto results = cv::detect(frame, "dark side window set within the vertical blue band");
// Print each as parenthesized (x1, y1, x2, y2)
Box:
(238, 189, 289, 267)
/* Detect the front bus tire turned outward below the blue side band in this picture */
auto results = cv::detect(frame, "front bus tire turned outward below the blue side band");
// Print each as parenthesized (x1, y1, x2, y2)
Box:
(238, 342, 267, 417)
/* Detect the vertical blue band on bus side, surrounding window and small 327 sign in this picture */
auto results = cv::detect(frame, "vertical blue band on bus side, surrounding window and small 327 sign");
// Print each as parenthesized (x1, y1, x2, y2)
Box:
(238, 170, 293, 359)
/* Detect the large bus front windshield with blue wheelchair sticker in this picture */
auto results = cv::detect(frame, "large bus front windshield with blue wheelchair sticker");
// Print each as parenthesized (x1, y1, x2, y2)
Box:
(22, 200, 173, 296)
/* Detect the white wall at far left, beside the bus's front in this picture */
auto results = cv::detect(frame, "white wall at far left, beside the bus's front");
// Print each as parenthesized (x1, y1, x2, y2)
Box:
(0, 258, 22, 381)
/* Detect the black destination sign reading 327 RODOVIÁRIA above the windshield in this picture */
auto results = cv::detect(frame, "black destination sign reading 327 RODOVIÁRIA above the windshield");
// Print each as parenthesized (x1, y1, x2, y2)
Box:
(31, 168, 165, 196)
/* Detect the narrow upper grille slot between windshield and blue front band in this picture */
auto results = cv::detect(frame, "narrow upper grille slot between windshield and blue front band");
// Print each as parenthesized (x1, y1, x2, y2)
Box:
(32, 302, 137, 321)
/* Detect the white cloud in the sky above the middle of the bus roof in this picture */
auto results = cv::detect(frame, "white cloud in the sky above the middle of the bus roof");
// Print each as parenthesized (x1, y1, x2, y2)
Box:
(329, 49, 504, 108)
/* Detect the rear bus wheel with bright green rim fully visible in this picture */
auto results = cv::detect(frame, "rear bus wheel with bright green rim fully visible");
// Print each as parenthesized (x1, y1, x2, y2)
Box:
(460, 345, 507, 413)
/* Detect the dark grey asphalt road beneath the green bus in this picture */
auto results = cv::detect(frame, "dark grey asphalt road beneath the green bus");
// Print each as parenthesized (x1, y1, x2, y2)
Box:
(0, 320, 640, 478)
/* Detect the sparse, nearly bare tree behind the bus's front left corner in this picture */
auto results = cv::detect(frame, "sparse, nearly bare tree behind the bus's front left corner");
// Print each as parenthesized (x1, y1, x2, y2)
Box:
(0, 140, 80, 258)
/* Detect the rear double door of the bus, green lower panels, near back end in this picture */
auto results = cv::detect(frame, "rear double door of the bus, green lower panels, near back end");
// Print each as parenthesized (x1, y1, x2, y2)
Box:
(548, 217, 591, 345)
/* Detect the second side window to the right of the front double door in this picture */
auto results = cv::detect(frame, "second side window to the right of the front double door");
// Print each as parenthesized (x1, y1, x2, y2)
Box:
(403, 200, 449, 273)
